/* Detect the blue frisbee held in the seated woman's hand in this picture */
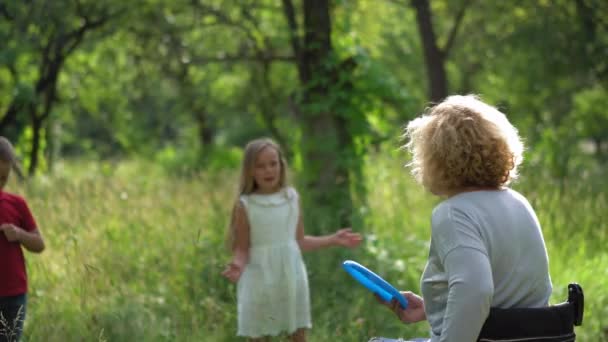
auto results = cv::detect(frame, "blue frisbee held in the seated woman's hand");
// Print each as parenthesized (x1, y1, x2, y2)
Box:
(342, 260, 407, 310)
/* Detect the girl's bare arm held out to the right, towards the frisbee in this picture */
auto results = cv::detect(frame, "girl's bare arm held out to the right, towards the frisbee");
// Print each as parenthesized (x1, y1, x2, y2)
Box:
(296, 200, 362, 252)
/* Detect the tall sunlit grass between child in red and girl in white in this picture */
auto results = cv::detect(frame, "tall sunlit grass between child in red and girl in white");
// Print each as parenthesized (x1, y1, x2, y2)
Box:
(16, 163, 233, 341)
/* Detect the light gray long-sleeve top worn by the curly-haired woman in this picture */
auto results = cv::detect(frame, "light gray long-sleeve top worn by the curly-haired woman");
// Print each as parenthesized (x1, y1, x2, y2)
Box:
(421, 188, 552, 342)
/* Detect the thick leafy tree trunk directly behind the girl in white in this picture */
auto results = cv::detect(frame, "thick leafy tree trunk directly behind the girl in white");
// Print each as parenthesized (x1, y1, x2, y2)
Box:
(296, 0, 360, 228)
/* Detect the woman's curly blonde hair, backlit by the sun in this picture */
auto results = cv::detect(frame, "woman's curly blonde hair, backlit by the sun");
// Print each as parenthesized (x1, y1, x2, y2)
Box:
(404, 95, 524, 195)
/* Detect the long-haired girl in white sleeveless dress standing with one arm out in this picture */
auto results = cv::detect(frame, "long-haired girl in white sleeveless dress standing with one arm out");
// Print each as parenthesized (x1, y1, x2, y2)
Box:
(222, 139, 362, 342)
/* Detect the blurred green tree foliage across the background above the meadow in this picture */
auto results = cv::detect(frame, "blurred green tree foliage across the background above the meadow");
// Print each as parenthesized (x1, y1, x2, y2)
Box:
(0, 0, 608, 182)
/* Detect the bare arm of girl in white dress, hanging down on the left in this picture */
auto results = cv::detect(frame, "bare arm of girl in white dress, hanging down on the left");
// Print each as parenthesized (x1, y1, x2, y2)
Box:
(222, 202, 249, 282)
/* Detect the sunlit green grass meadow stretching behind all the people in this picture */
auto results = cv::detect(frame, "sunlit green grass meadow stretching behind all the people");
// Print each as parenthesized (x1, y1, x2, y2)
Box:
(7, 156, 608, 342)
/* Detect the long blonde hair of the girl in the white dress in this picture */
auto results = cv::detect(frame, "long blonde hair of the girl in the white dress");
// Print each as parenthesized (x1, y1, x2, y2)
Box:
(226, 138, 287, 250)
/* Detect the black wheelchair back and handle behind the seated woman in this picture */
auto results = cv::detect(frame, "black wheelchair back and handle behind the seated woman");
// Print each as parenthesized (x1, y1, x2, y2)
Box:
(477, 283, 585, 342)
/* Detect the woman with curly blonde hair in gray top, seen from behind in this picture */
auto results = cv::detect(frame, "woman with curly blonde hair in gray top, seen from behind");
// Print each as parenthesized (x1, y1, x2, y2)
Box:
(372, 95, 552, 342)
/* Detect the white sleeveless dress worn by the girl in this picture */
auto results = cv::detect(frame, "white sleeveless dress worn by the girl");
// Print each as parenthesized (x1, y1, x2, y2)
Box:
(237, 187, 311, 338)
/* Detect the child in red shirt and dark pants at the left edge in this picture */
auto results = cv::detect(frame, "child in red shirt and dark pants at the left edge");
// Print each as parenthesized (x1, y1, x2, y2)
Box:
(0, 137, 44, 342)
